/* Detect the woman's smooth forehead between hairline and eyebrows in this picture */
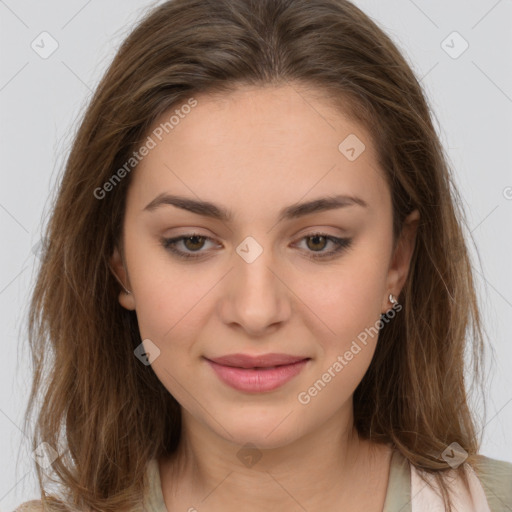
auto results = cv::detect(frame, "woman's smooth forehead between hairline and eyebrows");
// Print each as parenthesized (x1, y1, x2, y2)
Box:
(127, 85, 387, 218)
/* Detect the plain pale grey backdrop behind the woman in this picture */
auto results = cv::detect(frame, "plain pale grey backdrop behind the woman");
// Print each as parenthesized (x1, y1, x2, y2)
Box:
(0, 0, 512, 511)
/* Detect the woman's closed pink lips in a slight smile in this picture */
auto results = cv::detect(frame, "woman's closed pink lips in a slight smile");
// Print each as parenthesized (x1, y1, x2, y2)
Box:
(206, 354, 309, 393)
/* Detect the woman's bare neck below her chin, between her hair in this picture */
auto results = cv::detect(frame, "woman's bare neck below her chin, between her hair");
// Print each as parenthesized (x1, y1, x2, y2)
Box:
(161, 410, 387, 511)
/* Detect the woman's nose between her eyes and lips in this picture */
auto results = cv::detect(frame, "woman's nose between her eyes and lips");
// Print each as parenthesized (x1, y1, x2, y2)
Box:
(220, 239, 291, 337)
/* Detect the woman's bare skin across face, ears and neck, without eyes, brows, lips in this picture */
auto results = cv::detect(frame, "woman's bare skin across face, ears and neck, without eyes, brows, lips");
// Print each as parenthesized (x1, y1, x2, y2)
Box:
(112, 85, 418, 512)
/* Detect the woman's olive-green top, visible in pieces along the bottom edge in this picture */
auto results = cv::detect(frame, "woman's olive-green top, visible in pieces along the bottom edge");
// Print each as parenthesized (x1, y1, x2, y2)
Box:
(15, 450, 512, 512)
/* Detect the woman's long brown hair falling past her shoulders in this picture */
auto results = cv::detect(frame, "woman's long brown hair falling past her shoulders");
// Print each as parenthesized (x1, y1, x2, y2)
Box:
(21, 0, 483, 512)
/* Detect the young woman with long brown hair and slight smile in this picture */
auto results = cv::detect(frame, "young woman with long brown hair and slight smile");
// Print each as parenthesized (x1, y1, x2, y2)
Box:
(15, 0, 512, 512)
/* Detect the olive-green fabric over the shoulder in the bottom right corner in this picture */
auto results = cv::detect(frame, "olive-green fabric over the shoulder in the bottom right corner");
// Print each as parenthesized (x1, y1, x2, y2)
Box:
(471, 455, 512, 512)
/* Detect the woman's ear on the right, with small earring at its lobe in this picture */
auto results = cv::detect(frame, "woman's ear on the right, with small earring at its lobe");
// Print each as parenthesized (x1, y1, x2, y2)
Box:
(382, 210, 420, 313)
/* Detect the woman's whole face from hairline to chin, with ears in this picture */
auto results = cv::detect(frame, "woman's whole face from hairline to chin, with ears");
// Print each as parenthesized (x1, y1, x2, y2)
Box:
(111, 86, 413, 448)
